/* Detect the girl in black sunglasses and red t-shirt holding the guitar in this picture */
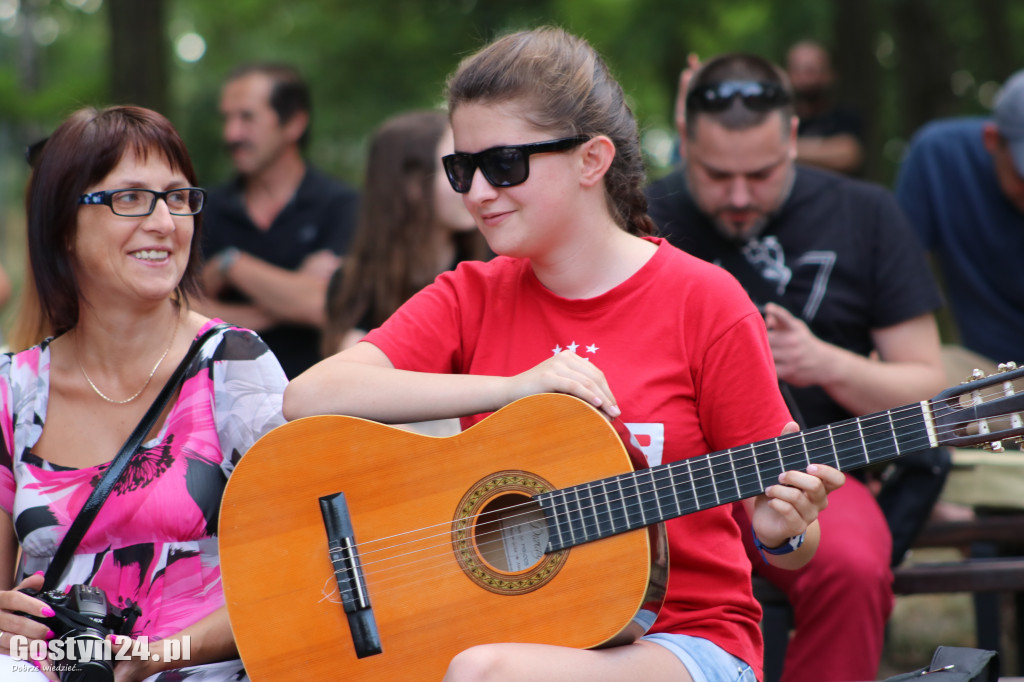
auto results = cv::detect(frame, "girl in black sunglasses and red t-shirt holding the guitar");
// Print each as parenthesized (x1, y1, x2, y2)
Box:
(285, 28, 843, 681)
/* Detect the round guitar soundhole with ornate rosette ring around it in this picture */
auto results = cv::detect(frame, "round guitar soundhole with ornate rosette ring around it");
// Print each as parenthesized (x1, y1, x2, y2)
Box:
(452, 471, 568, 595)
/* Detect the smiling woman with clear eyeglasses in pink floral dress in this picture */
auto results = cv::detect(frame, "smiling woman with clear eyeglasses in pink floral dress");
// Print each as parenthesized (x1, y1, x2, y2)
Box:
(0, 106, 286, 682)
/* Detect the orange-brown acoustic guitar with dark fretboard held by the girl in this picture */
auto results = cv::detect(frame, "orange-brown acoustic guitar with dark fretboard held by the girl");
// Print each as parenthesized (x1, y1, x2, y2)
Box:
(219, 367, 1024, 682)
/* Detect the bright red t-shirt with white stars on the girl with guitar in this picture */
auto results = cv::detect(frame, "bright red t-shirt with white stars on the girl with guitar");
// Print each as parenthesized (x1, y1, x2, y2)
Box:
(365, 239, 790, 678)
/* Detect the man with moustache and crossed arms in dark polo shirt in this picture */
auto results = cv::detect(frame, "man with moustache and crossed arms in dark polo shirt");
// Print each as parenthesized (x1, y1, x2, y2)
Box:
(201, 63, 357, 378)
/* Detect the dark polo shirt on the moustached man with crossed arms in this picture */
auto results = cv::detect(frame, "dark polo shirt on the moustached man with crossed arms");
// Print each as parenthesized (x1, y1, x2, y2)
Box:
(203, 165, 358, 379)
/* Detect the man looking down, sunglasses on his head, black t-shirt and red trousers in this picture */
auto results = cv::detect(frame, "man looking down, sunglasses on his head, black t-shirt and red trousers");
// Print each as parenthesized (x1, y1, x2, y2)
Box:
(648, 54, 945, 682)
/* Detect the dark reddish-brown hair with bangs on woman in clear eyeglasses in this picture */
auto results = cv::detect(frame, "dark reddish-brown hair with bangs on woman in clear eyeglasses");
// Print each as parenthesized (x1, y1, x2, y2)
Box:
(26, 106, 202, 334)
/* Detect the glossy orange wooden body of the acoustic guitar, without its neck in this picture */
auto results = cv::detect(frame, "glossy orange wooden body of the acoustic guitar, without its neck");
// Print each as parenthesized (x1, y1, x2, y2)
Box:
(219, 394, 660, 682)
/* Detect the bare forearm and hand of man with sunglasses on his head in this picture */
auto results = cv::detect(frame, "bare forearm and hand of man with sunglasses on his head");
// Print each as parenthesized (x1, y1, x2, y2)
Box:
(765, 303, 946, 415)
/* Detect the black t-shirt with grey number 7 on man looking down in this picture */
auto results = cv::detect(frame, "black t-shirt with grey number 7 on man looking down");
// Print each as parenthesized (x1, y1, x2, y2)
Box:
(647, 166, 942, 426)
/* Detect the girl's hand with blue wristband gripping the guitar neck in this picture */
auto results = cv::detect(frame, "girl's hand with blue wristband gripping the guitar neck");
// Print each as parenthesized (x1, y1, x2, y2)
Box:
(748, 422, 846, 568)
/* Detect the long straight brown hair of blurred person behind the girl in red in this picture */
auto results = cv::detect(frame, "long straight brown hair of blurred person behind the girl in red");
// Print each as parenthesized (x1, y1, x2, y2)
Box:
(323, 111, 489, 355)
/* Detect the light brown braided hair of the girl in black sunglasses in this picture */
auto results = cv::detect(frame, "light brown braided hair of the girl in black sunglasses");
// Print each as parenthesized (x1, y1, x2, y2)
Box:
(447, 27, 654, 235)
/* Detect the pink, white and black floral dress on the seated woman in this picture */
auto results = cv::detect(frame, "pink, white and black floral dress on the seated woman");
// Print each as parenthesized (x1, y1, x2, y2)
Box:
(0, 322, 287, 682)
